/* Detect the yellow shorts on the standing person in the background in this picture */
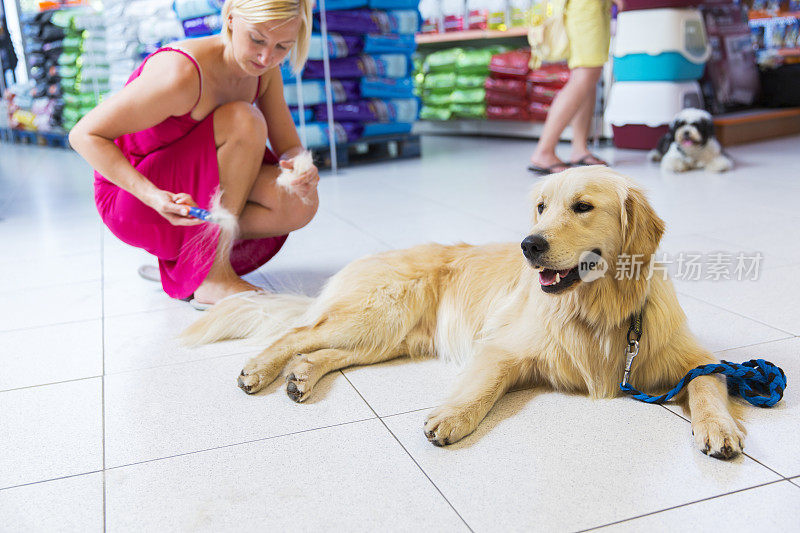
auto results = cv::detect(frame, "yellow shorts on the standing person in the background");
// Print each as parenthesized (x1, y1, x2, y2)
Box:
(564, 0, 611, 69)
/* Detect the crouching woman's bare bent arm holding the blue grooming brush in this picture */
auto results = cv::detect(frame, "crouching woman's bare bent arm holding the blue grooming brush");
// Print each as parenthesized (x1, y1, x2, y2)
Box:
(69, 52, 200, 224)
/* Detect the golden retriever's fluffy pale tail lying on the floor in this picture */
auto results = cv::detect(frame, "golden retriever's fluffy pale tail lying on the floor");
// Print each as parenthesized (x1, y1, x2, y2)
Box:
(180, 294, 314, 346)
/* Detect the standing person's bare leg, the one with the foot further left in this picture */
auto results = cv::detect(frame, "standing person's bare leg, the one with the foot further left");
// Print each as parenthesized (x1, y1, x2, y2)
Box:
(531, 67, 602, 172)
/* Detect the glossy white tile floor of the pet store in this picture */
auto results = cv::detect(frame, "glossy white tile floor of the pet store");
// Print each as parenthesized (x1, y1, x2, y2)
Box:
(0, 137, 800, 532)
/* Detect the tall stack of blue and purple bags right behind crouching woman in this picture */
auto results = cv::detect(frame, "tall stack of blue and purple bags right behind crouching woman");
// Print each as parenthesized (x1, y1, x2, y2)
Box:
(300, 0, 420, 147)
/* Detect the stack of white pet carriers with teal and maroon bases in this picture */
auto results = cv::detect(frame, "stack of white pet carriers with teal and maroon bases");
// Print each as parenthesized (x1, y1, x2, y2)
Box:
(605, 0, 711, 150)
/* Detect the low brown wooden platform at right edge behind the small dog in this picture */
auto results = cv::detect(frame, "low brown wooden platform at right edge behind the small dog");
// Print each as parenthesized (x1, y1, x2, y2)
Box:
(714, 107, 800, 146)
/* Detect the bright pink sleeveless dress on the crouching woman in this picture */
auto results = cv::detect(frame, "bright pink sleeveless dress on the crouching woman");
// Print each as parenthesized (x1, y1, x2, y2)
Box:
(94, 48, 287, 298)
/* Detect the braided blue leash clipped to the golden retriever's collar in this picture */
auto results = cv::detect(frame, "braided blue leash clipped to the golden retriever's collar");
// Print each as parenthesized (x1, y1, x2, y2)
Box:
(619, 306, 786, 407)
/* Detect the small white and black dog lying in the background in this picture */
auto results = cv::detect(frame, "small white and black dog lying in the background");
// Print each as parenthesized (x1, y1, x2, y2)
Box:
(648, 108, 733, 172)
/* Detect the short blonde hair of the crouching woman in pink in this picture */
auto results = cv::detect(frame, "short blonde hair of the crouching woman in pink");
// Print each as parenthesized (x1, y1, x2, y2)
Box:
(221, 0, 313, 74)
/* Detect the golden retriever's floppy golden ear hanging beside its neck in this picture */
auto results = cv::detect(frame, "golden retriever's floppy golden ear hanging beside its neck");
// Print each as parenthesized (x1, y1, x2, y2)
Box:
(622, 185, 665, 262)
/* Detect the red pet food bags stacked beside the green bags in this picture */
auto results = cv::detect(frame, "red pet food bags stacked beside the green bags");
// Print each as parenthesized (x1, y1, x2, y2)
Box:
(485, 50, 569, 122)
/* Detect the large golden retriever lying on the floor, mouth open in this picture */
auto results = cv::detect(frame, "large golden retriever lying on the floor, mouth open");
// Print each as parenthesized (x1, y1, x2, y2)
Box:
(183, 166, 744, 459)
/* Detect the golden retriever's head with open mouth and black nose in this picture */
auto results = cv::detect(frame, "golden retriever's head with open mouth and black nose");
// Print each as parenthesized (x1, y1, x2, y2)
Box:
(522, 166, 663, 294)
